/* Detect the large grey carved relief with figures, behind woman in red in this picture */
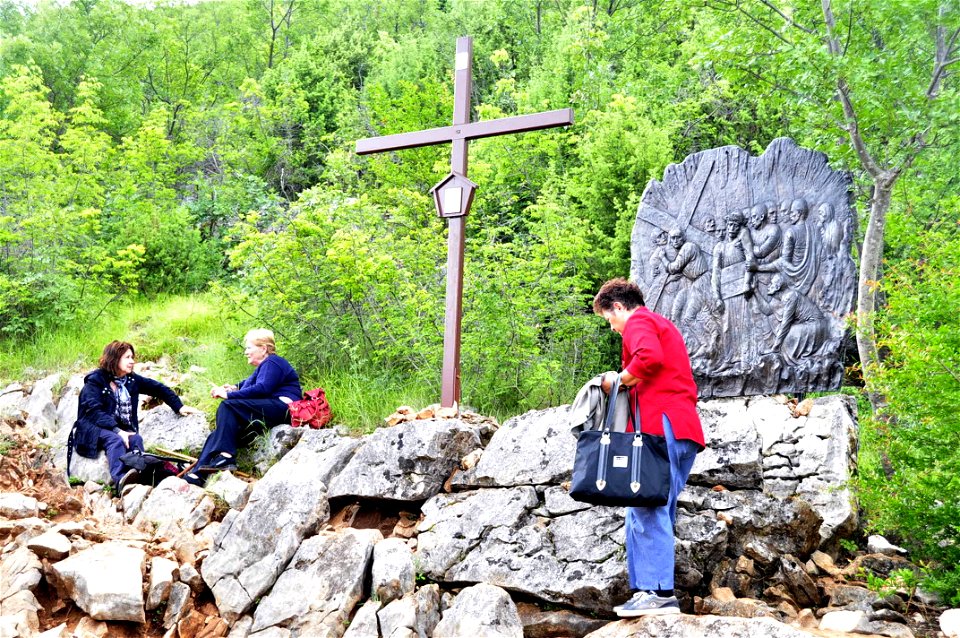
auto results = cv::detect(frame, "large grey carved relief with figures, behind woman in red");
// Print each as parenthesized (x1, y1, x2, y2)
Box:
(630, 138, 856, 398)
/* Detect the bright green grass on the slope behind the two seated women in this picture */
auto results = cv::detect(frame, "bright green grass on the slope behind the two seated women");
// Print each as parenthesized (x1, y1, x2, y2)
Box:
(0, 294, 512, 434)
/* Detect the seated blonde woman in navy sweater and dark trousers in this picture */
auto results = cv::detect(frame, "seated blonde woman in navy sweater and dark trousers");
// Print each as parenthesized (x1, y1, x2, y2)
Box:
(184, 329, 303, 485)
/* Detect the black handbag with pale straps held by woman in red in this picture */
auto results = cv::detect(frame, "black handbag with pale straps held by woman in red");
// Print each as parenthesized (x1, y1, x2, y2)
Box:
(570, 377, 670, 507)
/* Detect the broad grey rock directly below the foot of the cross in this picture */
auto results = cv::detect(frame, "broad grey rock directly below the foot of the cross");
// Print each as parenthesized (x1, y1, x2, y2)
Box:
(330, 419, 480, 501)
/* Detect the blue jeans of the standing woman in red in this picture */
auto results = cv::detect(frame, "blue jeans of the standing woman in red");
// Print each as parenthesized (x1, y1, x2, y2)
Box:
(626, 414, 700, 590)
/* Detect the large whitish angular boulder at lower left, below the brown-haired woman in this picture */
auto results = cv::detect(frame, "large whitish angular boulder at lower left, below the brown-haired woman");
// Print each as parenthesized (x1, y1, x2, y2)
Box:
(52, 541, 146, 623)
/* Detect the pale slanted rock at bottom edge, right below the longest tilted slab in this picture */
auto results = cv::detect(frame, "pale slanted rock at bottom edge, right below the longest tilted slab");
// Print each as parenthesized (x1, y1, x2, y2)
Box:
(251, 529, 382, 636)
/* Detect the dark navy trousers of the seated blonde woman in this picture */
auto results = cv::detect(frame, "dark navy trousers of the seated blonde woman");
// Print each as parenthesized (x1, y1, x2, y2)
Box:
(197, 399, 290, 467)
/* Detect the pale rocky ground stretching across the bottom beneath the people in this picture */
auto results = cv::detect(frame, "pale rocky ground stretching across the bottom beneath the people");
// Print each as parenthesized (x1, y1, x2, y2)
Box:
(0, 376, 960, 638)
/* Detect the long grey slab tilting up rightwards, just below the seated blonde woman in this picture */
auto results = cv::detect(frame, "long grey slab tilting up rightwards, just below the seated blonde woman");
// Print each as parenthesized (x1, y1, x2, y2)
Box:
(200, 445, 330, 623)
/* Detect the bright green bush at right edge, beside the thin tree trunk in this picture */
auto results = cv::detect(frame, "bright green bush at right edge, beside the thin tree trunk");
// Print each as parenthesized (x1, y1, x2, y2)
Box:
(861, 216, 960, 597)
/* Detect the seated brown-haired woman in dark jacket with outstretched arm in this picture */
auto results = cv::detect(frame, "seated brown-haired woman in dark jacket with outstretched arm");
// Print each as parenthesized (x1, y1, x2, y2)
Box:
(67, 341, 199, 488)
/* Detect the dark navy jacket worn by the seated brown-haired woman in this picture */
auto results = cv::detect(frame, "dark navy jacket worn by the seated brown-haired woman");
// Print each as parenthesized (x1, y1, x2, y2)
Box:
(72, 368, 183, 459)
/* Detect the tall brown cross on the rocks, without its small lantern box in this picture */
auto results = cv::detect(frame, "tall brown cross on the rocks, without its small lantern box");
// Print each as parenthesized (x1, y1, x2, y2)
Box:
(356, 37, 573, 407)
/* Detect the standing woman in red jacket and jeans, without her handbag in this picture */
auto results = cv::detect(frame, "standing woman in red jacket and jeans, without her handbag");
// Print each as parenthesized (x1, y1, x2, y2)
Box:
(593, 279, 704, 618)
